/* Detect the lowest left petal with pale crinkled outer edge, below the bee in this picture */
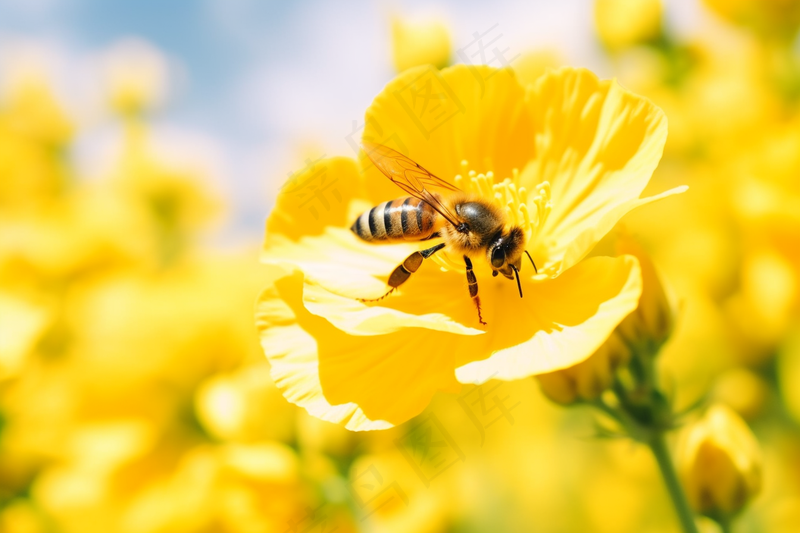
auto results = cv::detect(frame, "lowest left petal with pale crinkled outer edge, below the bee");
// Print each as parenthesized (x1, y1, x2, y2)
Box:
(256, 265, 458, 431)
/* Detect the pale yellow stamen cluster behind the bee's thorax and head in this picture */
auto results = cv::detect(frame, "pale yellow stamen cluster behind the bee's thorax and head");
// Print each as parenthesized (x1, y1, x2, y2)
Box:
(434, 160, 552, 270)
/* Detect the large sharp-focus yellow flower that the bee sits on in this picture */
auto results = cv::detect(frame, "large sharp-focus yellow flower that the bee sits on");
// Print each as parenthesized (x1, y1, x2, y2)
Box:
(257, 66, 680, 430)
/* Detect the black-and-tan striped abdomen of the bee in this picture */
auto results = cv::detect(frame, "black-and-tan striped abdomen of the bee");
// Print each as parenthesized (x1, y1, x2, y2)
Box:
(350, 196, 438, 242)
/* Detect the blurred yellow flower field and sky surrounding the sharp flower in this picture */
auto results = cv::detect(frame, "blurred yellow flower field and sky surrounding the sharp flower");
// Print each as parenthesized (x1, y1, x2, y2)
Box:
(0, 0, 800, 533)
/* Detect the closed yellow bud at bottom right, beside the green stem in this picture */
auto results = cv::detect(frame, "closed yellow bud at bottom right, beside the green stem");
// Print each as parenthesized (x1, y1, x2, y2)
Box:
(677, 404, 761, 519)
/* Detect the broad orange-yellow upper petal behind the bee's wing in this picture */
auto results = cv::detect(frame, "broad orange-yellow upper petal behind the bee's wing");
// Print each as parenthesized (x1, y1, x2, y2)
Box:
(362, 65, 533, 203)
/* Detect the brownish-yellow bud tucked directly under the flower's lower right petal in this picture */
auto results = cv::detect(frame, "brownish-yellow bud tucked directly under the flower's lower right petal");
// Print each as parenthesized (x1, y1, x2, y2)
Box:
(536, 333, 631, 405)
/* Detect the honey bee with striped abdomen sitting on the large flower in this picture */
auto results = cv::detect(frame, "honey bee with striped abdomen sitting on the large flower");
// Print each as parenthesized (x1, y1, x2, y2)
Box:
(350, 142, 538, 325)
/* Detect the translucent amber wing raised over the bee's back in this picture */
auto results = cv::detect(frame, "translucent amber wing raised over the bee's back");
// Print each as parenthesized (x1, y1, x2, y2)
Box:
(361, 141, 460, 226)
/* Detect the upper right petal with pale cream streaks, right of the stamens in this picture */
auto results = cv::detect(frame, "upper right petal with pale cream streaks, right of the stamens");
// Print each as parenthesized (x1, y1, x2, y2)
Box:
(521, 68, 667, 272)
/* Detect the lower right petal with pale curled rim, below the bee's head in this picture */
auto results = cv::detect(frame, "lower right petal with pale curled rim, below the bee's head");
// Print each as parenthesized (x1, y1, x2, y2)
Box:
(456, 256, 642, 383)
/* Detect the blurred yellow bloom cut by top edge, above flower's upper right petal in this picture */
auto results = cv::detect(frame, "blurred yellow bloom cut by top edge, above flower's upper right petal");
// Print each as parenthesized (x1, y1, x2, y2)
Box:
(594, 0, 663, 51)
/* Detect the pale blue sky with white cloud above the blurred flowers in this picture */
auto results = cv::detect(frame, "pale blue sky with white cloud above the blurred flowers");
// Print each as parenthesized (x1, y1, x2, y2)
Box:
(0, 0, 696, 235)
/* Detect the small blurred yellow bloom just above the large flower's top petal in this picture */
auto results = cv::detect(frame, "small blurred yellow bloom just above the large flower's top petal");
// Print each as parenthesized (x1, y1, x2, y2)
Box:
(392, 16, 452, 72)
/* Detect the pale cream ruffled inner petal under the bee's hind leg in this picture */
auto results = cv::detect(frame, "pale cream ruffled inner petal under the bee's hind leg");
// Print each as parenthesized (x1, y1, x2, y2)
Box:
(262, 227, 483, 335)
